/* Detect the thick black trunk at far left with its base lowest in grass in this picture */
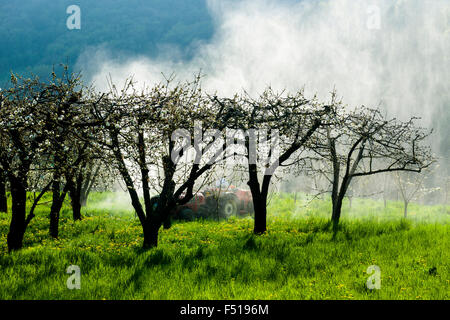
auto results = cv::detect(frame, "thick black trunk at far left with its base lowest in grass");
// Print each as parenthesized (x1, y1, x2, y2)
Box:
(7, 179, 27, 252)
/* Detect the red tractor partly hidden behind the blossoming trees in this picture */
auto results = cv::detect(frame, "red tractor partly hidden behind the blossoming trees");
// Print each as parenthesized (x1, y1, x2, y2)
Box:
(173, 186, 253, 220)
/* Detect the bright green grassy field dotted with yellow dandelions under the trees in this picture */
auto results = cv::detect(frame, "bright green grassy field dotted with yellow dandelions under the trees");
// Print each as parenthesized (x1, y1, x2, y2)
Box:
(0, 193, 450, 299)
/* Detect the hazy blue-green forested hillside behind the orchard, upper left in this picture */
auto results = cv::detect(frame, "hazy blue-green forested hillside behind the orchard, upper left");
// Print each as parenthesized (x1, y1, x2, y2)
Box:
(0, 0, 213, 87)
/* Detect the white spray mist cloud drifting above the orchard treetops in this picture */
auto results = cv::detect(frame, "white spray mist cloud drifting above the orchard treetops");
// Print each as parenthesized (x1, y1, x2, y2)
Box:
(79, 0, 450, 146)
